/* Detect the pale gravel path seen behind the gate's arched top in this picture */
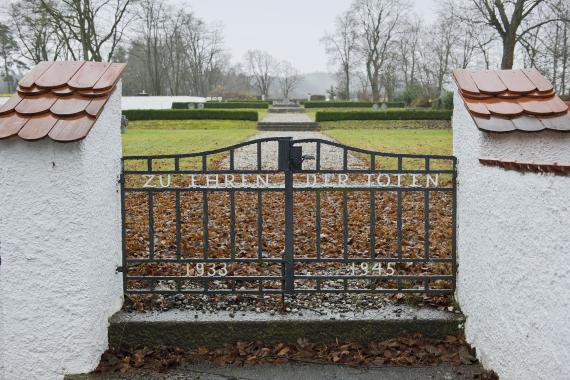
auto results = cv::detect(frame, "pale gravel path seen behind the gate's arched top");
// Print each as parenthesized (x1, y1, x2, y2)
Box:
(221, 132, 366, 170)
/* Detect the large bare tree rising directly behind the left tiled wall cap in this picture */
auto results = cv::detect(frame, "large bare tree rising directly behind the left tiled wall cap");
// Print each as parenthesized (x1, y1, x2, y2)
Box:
(40, 0, 133, 61)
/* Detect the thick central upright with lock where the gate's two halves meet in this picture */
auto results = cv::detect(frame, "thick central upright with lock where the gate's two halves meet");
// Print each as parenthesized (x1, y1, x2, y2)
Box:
(279, 138, 295, 294)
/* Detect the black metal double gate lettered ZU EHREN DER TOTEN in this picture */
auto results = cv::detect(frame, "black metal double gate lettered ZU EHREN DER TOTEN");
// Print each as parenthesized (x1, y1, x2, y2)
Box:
(119, 138, 456, 294)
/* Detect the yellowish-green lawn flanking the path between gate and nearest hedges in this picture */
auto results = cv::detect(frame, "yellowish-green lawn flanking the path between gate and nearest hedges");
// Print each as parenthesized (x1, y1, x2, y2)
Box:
(123, 120, 452, 171)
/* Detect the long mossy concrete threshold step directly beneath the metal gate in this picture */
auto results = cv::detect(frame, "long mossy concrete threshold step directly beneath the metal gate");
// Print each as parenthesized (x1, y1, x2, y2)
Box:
(109, 305, 464, 348)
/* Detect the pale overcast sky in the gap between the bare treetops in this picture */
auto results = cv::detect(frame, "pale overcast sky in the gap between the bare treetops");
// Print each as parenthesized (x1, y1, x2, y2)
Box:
(184, 0, 436, 72)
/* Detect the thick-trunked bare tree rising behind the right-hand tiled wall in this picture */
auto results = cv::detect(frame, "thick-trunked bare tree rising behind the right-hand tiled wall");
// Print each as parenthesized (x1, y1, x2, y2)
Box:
(472, 0, 556, 69)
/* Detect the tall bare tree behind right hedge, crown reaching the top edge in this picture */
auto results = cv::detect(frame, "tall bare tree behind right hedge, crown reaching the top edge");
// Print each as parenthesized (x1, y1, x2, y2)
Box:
(353, 0, 407, 102)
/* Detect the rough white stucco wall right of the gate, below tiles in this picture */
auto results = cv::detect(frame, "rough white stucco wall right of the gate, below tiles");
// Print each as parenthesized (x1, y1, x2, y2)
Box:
(453, 86, 570, 380)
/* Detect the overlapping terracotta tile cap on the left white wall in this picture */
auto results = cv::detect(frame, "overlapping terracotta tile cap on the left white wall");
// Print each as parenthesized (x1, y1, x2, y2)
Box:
(0, 61, 126, 142)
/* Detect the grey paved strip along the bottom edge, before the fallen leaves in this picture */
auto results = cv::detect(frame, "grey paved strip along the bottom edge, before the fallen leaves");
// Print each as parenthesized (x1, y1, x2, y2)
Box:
(66, 364, 483, 380)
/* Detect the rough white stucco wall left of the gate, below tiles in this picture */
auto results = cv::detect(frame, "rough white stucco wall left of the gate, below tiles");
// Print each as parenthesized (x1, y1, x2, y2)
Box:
(0, 85, 122, 380)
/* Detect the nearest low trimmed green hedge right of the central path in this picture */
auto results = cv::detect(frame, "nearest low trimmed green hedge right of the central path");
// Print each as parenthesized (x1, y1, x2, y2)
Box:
(316, 109, 452, 122)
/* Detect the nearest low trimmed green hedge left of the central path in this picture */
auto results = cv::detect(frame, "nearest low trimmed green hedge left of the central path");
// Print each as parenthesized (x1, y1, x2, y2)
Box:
(123, 109, 258, 121)
